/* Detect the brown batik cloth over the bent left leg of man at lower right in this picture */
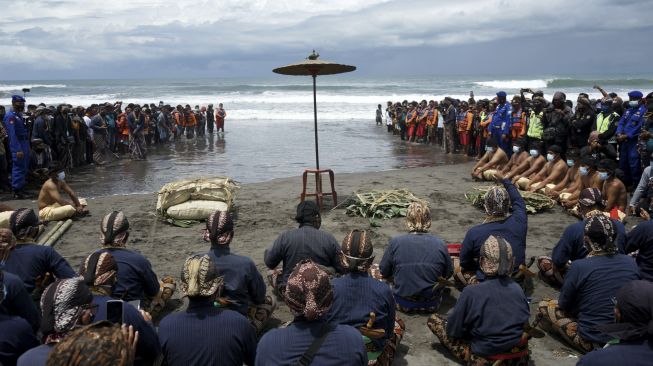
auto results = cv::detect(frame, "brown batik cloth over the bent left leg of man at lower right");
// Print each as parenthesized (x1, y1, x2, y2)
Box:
(537, 300, 600, 353)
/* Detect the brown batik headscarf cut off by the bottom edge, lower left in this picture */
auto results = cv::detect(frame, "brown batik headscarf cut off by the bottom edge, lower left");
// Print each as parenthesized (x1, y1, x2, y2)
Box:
(46, 321, 132, 366)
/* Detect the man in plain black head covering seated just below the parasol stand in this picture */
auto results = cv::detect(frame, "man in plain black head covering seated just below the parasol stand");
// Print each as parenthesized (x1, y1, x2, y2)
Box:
(264, 201, 342, 294)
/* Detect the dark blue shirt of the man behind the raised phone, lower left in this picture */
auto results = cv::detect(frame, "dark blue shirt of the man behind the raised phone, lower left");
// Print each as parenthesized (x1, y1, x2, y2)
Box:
(93, 295, 161, 365)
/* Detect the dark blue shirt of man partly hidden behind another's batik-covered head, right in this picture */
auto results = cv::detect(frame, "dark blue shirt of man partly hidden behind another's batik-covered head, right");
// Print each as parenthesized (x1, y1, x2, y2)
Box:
(551, 219, 626, 268)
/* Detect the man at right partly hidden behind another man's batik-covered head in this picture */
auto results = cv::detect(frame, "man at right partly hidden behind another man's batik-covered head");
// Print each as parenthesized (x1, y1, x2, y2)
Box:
(537, 188, 626, 288)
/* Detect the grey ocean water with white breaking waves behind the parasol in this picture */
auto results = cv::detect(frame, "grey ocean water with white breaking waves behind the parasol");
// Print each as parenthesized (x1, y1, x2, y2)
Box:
(0, 73, 653, 196)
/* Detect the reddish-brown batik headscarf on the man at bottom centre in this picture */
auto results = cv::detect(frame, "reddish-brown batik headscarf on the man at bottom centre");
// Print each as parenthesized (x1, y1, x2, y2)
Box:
(284, 260, 333, 320)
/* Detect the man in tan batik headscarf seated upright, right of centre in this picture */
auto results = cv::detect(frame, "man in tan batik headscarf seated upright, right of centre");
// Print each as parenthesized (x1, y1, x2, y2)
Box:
(379, 202, 453, 313)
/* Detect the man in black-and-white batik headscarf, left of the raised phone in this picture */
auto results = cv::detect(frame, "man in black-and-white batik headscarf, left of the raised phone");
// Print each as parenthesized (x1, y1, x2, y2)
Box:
(17, 277, 94, 366)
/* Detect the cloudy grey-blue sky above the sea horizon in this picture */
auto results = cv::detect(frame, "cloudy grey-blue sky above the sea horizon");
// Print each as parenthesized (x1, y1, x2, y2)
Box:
(0, 0, 653, 80)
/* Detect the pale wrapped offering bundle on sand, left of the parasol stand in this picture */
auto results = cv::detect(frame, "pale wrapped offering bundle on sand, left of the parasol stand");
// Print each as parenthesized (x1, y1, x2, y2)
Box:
(156, 177, 239, 226)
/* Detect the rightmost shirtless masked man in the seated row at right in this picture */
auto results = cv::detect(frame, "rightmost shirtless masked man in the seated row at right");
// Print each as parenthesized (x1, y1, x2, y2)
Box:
(598, 159, 628, 221)
